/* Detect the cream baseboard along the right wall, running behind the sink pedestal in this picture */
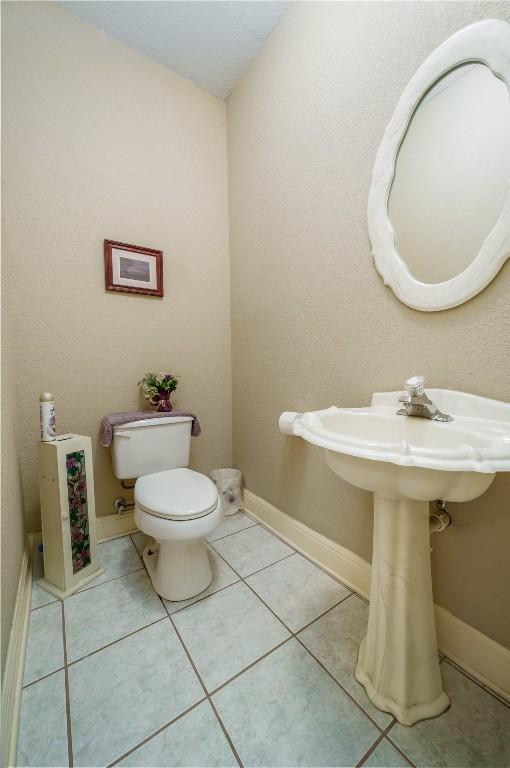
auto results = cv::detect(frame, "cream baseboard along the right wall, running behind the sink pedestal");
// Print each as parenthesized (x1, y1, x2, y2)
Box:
(244, 490, 510, 700)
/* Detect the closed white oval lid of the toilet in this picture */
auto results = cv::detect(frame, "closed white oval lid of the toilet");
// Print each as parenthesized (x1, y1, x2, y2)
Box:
(135, 469, 218, 520)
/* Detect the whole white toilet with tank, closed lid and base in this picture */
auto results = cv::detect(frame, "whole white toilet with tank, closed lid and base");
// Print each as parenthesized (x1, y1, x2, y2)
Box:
(112, 416, 223, 600)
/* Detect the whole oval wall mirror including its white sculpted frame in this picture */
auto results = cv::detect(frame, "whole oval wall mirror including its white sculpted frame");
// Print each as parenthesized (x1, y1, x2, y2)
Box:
(369, 21, 510, 311)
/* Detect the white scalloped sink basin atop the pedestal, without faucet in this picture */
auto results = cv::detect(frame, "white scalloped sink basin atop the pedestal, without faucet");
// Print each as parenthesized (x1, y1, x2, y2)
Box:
(280, 389, 510, 501)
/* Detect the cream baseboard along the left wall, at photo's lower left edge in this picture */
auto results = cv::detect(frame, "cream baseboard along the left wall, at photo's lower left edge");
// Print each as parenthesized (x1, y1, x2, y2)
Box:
(2, 536, 33, 766)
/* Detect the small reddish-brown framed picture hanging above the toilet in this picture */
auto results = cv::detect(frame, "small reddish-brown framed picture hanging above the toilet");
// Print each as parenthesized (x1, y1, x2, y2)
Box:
(104, 240, 163, 296)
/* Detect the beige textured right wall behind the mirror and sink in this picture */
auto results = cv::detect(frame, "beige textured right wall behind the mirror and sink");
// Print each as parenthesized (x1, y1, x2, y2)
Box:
(228, 2, 510, 645)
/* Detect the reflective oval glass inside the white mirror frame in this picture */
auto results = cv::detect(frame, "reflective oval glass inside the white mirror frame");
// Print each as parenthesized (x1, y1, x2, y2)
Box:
(388, 63, 510, 283)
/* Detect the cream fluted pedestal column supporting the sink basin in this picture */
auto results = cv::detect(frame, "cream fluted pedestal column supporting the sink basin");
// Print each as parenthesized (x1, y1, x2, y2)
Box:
(355, 494, 450, 725)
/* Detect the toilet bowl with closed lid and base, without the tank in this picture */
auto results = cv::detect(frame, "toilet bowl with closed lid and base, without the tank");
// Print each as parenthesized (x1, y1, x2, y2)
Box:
(135, 468, 223, 601)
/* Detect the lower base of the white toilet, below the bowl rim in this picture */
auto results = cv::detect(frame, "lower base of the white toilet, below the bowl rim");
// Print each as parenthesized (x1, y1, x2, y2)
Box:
(143, 538, 212, 601)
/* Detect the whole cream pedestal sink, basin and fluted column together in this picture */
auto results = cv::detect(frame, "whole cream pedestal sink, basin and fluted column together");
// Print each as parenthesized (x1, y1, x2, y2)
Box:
(279, 389, 510, 725)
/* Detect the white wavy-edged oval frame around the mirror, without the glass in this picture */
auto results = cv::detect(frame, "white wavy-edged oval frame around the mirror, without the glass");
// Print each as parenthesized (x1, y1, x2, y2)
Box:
(368, 19, 510, 312)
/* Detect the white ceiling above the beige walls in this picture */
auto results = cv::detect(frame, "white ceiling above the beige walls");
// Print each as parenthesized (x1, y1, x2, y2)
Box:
(60, 0, 288, 99)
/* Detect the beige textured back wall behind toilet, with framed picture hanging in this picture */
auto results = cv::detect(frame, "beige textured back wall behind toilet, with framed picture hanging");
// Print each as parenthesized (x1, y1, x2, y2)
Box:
(3, 2, 232, 530)
